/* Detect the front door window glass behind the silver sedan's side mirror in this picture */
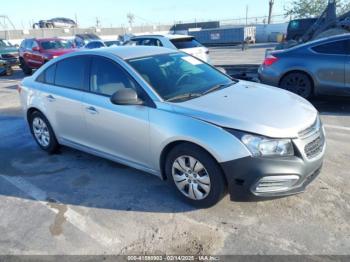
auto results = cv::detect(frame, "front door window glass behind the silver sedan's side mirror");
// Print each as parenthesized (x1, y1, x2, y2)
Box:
(90, 57, 138, 96)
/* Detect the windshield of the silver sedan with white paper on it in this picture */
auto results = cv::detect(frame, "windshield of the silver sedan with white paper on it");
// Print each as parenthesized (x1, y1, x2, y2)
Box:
(128, 53, 236, 102)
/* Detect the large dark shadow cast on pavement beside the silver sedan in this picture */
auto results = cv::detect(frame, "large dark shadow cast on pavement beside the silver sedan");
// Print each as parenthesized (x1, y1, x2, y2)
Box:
(0, 112, 197, 213)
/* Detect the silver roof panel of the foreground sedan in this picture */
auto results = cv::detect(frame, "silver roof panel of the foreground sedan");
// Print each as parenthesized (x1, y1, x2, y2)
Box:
(91, 46, 176, 60)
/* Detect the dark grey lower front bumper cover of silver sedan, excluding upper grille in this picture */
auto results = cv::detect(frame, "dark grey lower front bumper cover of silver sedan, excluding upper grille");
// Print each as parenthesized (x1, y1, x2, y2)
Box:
(221, 156, 323, 201)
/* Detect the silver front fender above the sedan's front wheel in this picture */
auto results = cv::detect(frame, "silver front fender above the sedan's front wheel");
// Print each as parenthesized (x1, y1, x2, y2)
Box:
(149, 105, 250, 171)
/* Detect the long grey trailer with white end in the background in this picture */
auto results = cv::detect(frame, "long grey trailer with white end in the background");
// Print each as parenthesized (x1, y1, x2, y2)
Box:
(188, 26, 256, 46)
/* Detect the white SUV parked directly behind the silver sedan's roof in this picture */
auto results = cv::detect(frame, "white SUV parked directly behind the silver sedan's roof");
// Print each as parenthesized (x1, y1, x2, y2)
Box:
(124, 35, 209, 63)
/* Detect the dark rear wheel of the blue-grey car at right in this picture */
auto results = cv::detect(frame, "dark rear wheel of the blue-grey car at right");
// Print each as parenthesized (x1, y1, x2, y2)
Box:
(280, 72, 313, 99)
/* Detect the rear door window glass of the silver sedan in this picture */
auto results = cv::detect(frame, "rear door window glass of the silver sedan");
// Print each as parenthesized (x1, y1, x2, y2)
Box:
(55, 56, 90, 90)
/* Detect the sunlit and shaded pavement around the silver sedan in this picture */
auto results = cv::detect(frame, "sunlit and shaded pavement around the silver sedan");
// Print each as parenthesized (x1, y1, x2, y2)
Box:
(0, 68, 350, 255)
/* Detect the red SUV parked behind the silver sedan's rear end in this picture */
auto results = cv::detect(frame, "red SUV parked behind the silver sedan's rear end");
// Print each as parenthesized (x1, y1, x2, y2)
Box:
(19, 38, 77, 75)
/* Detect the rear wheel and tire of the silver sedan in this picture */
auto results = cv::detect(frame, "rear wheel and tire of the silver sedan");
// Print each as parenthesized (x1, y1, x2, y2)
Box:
(28, 111, 59, 154)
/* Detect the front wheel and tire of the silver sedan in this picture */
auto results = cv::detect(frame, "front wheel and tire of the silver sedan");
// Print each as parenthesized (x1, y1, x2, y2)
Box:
(165, 144, 226, 208)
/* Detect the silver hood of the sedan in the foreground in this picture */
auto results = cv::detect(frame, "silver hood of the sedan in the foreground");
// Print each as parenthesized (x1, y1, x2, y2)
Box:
(172, 81, 318, 138)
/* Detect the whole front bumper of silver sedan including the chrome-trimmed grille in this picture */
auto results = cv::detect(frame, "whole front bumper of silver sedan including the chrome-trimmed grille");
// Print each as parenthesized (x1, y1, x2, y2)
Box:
(221, 118, 326, 201)
